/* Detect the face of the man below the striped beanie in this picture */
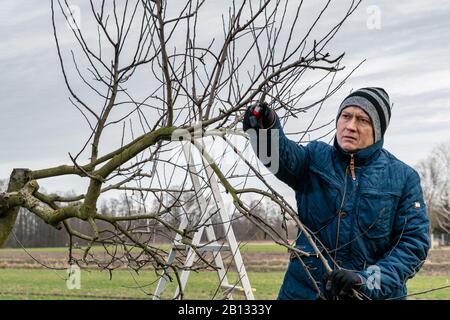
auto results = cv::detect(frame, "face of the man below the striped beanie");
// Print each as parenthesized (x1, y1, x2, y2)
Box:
(337, 106, 374, 153)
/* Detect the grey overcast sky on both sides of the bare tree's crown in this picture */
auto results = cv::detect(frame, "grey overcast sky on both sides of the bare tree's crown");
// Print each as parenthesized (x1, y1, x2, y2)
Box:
(0, 0, 450, 195)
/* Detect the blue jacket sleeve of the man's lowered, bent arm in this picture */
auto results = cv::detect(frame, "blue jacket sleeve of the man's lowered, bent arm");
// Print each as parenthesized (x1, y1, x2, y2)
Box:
(359, 171, 429, 299)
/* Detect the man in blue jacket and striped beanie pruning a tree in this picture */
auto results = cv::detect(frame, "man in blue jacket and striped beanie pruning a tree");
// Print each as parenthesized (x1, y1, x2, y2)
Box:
(243, 88, 429, 299)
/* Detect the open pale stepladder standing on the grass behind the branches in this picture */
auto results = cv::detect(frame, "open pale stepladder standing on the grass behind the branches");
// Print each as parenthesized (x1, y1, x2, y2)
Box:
(153, 142, 255, 300)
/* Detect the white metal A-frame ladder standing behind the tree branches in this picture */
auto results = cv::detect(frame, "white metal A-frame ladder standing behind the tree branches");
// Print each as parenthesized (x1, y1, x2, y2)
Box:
(153, 142, 255, 300)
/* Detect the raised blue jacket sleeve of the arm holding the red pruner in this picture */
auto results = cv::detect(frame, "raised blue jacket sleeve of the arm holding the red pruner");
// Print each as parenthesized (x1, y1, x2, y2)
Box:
(249, 115, 309, 190)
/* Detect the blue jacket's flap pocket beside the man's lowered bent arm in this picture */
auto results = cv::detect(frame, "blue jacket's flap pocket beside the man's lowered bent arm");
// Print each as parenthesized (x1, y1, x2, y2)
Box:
(357, 191, 398, 240)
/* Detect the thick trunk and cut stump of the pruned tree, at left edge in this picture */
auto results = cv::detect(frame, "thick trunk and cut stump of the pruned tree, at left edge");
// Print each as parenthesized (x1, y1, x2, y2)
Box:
(0, 169, 29, 247)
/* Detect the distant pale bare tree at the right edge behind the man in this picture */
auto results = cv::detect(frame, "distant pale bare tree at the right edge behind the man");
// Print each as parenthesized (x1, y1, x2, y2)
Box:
(417, 143, 450, 233)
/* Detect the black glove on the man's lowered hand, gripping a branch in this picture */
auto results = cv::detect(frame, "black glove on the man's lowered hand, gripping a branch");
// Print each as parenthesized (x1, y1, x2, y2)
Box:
(326, 269, 363, 297)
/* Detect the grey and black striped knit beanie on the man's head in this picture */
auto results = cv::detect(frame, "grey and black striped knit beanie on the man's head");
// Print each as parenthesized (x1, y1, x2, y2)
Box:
(336, 87, 391, 143)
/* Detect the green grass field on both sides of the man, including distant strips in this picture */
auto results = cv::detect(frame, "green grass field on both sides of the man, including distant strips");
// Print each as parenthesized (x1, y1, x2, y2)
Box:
(0, 244, 450, 300)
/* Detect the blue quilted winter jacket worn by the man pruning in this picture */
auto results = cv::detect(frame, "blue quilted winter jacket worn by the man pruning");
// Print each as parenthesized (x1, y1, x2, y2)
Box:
(256, 117, 429, 299)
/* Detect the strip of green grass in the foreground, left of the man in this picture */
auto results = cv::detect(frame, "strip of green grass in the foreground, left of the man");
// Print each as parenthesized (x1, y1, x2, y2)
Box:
(0, 269, 283, 299)
